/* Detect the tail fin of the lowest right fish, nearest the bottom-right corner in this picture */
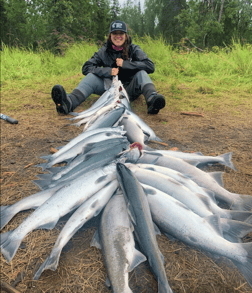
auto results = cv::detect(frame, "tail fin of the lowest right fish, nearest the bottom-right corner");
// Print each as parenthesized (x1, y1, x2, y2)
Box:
(233, 242, 252, 287)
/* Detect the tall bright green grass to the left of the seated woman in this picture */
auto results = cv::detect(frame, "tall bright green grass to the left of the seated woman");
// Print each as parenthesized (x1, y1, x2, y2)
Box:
(1, 42, 97, 87)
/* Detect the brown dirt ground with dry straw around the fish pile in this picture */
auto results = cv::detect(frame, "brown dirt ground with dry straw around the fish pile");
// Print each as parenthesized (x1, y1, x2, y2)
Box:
(1, 92, 252, 293)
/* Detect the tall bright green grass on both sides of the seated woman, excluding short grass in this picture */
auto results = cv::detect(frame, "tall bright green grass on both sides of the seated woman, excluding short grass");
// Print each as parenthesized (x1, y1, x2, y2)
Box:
(1, 36, 252, 90)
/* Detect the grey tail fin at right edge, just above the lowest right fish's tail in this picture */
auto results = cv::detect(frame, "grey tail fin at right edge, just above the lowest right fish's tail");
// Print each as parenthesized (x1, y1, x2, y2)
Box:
(220, 219, 252, 242)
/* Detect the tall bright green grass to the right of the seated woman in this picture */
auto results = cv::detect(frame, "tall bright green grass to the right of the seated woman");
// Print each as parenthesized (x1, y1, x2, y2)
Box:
(135, 36, 252, 86)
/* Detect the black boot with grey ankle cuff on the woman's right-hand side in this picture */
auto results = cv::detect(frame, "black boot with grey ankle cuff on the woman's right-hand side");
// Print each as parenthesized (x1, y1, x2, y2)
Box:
(143, 83, 165, 114)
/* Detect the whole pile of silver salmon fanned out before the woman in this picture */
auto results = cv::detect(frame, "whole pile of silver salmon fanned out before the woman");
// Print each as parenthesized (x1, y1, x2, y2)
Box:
(1, 77, 252, 293)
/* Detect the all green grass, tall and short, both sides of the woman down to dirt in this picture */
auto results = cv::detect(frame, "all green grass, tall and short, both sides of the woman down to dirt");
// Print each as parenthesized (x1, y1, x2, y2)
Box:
(1, 36, 252, 112)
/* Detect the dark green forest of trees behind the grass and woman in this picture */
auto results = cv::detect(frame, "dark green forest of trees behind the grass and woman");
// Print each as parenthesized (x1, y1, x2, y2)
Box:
(0, 0, 252, 55)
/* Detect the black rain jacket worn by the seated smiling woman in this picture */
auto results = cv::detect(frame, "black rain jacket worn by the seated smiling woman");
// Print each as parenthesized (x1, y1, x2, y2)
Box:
(82, 38, 155, 86)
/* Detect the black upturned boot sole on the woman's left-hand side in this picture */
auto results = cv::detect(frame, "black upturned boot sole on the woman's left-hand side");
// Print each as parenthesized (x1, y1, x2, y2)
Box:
(52, 84, 71, 114)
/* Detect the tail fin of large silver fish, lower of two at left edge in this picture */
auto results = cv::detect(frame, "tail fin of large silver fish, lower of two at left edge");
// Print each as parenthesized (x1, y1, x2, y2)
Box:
(1, 230, 23, 263)
